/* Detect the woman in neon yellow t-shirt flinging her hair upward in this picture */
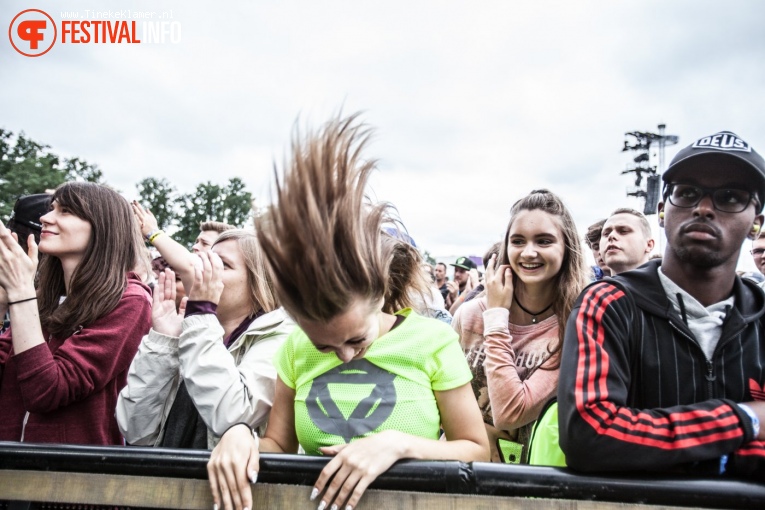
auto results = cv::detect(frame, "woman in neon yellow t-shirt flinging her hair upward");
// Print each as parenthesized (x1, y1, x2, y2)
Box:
(208, 116, 489, 509)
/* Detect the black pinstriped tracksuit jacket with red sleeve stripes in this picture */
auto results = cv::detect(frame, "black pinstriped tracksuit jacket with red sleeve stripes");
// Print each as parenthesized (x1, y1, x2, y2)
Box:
(558, 260, 765, 479)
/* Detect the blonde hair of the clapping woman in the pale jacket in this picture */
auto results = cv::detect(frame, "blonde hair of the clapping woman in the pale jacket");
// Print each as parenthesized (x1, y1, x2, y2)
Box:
(213, 229, 279, 317)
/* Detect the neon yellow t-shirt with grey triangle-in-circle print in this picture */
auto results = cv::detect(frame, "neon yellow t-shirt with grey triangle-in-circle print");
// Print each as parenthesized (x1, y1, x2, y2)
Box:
(274, 308, 472, 455)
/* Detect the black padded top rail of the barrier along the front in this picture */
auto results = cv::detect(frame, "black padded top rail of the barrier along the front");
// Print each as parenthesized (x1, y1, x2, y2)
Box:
(0, 442, 765, 509)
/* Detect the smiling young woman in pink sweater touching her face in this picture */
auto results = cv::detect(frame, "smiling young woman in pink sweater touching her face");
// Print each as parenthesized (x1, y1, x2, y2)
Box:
(452, 189, 587, 462)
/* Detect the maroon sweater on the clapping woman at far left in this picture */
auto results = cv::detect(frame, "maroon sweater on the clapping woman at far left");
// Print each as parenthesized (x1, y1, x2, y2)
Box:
(0, 273, 151, 445)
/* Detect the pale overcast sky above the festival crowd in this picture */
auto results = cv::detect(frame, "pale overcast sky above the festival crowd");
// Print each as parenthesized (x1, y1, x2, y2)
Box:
(0, 0, 765, 267)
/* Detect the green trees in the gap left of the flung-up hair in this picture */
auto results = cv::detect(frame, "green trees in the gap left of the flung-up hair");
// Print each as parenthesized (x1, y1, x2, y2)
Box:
(173, 177, 252, 246)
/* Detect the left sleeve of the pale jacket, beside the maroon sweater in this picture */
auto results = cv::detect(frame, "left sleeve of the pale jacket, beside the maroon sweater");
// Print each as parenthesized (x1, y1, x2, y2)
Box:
(116, 329, 180, 446)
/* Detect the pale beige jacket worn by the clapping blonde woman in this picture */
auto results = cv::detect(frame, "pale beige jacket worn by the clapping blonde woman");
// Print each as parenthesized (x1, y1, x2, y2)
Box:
(117, 308, 295, 447)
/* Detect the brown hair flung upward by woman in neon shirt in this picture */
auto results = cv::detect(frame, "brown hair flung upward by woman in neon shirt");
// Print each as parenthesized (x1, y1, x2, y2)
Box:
(254, 114, 428, 323)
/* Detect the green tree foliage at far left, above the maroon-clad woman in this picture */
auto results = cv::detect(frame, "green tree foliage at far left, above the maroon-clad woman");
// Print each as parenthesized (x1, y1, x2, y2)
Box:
(0, 129, 103, 222)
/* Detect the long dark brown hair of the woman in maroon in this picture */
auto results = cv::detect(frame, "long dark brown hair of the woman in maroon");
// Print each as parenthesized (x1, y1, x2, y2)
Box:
(37, 182, 143, 337)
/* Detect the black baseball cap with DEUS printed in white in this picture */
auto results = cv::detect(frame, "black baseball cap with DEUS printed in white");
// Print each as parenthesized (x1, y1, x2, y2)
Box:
(662, 131, 765, 212)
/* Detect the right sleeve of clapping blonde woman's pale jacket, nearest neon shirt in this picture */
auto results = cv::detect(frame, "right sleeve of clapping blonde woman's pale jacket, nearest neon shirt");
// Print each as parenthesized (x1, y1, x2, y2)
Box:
(179, 314, 286, 436)
